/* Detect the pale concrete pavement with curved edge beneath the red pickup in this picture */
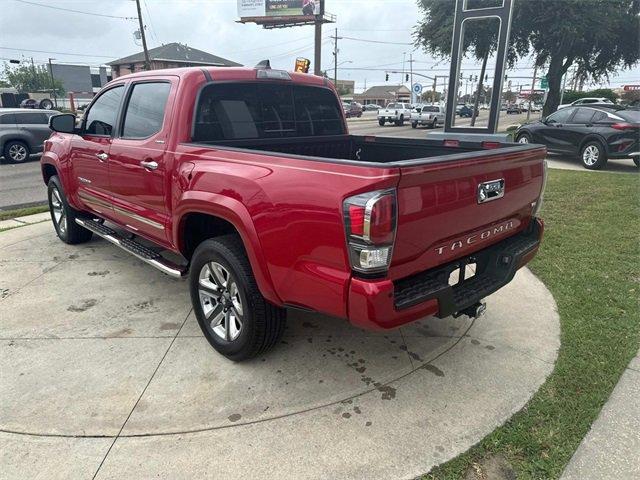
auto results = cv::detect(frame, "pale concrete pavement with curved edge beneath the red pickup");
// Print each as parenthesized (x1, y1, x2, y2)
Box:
(0, 222, 560, 479)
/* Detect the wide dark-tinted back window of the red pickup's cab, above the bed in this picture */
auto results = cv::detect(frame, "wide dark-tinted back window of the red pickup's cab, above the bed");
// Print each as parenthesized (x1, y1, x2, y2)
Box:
(192, 83, 344, 142)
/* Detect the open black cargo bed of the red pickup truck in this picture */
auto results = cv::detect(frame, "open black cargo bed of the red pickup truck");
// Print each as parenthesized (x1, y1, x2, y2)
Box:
(189, 135, 539, 167)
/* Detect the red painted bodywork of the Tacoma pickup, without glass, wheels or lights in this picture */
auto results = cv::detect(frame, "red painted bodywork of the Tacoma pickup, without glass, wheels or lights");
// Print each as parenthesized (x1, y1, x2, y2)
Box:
(41, 68, 545, 328)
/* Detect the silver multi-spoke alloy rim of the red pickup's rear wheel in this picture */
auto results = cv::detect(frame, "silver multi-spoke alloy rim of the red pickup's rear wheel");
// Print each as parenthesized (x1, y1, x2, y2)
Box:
(198, 262, 244, 342)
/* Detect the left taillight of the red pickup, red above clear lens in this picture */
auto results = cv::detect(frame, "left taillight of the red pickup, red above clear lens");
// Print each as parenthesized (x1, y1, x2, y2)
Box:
(344, 190, 397, 273)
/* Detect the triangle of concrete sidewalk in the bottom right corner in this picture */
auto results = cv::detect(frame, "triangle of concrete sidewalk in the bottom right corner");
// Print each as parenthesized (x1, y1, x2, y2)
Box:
(561, 352, 640, 480)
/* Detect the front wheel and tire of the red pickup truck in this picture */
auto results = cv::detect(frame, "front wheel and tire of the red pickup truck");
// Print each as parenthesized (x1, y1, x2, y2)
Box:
(47, 175, 93, 245)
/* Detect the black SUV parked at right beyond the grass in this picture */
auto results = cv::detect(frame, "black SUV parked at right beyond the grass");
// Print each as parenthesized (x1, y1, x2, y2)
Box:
(515, 105, 640, 170)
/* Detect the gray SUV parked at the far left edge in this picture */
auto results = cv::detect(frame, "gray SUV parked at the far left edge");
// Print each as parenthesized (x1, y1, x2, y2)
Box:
(0, 108, 60, 163)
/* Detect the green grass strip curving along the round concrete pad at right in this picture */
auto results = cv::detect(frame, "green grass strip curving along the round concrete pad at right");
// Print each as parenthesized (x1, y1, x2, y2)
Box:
(423, 170, 640, 480)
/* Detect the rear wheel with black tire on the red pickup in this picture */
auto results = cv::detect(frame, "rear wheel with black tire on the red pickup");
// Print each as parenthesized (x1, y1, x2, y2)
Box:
(189, 235, 286, 362)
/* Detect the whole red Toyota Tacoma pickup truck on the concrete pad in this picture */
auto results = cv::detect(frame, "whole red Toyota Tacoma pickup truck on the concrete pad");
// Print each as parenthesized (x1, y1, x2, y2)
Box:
(41, 67, 546, 360)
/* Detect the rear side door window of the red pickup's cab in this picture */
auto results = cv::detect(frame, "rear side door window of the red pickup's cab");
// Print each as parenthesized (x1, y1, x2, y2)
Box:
(122, 82, 171, 139)
